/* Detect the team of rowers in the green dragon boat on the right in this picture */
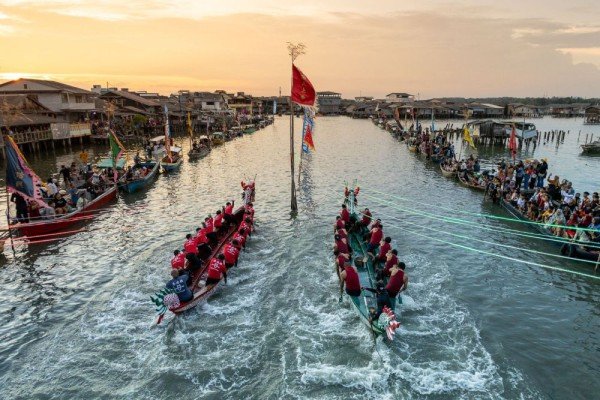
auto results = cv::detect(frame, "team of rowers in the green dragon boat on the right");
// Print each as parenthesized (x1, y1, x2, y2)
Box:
(333, 204, 408, 320)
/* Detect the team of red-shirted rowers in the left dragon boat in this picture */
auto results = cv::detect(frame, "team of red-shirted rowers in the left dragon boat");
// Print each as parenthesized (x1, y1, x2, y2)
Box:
(166, 200, 254, 302)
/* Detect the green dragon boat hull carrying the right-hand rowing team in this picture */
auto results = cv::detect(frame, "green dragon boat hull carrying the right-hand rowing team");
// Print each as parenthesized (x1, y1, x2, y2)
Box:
(336, 194, 398, 340)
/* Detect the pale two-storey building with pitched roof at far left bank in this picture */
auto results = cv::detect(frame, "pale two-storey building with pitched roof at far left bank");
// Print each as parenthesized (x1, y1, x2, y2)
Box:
(0, 78, 95, 122)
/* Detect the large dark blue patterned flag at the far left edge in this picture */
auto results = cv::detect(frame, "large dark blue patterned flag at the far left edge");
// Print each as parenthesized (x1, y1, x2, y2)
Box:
(4, 135, 48, 208)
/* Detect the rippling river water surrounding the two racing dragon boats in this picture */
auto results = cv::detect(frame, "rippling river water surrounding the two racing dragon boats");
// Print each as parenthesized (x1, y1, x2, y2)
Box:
(0, 117, 600, 399)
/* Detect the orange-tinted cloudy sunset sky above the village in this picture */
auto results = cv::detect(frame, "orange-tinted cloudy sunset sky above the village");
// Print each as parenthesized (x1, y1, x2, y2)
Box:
(0, 0, 600, 99)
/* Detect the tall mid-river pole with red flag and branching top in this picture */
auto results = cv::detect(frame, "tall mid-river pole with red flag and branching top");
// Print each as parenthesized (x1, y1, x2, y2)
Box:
(288, 42, 316, 213)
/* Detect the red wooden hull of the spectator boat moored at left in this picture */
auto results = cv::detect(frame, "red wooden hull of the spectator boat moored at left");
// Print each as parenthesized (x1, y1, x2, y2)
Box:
(9, 186, 117, 237)
